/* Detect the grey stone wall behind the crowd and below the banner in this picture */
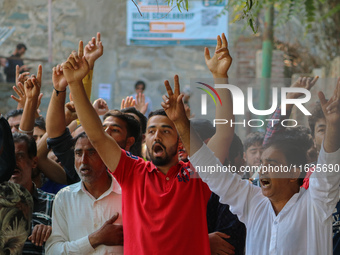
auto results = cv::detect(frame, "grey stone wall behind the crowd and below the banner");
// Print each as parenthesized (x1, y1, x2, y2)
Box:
(0, 0, 292, 140)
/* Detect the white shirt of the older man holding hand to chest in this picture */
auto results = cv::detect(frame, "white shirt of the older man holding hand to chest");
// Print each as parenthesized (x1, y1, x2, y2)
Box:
(46, 174, 124, 255)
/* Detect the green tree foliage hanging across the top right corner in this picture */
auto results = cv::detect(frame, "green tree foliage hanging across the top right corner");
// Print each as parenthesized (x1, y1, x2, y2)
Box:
(132, 0, 340, 72)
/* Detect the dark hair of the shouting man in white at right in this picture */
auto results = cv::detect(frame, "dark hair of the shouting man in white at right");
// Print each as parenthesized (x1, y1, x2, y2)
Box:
(265, 132, 307, 186)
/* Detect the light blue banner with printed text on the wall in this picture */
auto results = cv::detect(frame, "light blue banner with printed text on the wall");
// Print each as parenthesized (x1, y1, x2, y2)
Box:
(127, 0, 228, 46)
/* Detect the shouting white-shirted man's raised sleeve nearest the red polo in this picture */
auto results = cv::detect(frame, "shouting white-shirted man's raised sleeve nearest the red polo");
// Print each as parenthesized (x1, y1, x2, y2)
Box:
(190, 144, 264, 225)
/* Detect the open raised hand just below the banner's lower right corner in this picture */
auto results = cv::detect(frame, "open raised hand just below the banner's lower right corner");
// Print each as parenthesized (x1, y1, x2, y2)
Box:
(204, 33, 232, 78)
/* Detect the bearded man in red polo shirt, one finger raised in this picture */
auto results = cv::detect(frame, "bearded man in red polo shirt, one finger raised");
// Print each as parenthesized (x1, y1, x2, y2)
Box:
(63, 35, 233, 255)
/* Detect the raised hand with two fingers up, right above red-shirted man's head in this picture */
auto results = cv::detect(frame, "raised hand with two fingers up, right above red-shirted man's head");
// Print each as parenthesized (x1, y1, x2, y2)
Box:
(161, 75, 186, 122)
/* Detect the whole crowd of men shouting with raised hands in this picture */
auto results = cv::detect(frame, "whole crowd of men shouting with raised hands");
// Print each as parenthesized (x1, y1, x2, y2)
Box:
(0, 33, 340, 255)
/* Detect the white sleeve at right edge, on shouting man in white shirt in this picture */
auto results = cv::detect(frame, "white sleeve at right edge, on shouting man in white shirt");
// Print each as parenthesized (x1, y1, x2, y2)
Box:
(308, 144, 340, 221)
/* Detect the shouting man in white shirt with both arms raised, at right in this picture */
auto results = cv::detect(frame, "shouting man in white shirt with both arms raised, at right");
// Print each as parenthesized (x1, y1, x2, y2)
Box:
(162, 63, 340, 255)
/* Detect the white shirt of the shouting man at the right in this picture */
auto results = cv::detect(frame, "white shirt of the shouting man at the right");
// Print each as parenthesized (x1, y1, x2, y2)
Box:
(190, 142, 340, 255)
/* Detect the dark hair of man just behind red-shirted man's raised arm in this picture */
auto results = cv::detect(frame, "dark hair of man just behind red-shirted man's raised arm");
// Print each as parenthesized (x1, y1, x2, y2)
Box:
(103, 110, 141, 141)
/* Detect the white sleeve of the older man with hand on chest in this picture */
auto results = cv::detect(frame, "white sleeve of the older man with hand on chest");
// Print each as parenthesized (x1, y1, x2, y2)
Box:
(45, 193, 94, 255)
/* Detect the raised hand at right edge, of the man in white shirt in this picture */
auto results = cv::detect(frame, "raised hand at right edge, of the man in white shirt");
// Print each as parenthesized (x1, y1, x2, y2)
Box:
(318, 78, 340, 126)
